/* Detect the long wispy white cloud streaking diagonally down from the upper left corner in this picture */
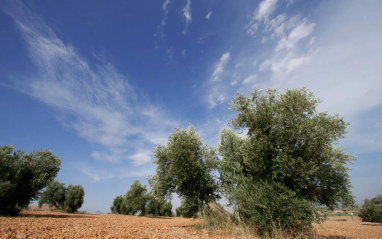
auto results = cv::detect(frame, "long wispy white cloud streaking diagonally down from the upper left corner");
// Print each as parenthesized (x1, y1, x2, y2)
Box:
(6, 1, 177, 176)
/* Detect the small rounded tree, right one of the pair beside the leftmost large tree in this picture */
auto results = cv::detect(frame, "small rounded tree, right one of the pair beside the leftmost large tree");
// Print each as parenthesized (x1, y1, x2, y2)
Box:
(64, 185, 85, 213)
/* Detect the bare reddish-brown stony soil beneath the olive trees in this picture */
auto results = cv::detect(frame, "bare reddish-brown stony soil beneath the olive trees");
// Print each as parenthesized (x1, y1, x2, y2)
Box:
(0, 211, 382, 239)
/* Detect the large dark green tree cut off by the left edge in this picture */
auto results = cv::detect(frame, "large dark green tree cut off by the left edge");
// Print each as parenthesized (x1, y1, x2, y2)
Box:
(0, 145, 61, 215)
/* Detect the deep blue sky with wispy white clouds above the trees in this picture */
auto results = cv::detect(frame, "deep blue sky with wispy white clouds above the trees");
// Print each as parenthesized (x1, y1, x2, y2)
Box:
(0, 0, 382, 213)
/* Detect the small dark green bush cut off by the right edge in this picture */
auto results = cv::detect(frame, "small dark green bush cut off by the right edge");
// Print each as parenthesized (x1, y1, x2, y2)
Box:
(358, 194, 382, 223)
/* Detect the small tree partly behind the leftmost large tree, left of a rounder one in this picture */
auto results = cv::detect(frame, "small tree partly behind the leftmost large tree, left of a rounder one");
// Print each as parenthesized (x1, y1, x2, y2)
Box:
(38, 180, 66, 208)
